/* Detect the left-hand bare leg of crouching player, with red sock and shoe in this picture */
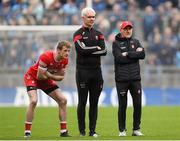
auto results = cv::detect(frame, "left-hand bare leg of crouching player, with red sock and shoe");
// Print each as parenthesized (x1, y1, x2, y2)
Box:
(25, 90, 38, 136)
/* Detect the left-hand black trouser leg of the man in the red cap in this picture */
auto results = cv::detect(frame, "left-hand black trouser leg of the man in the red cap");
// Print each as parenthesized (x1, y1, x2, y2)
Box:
(116, 82, 128, 132)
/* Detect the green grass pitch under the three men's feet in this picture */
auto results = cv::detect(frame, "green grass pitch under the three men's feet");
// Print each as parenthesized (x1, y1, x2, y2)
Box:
(0, 106, 180, 140)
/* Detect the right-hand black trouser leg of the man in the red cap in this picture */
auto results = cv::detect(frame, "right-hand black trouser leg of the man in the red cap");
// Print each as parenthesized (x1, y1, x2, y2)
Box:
(130, 81, 142, 130)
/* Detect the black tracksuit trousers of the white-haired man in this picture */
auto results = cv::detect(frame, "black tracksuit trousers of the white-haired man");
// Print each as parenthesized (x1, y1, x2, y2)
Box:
(76, 69, 103, 133)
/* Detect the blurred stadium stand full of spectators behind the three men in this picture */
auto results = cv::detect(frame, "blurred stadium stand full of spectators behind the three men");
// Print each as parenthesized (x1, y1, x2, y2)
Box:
(0, 0, 180, 88)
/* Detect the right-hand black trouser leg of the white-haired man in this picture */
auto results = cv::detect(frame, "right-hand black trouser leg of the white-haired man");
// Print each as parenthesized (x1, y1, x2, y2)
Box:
(89, 70, 103, 136)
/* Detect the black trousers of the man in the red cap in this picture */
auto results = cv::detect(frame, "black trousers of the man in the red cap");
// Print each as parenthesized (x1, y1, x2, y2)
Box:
(116, 81, 142, 132)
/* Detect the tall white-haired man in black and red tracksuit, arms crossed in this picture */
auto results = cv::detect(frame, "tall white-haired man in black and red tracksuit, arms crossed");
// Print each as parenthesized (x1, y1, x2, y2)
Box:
(73, 8, 106, 137)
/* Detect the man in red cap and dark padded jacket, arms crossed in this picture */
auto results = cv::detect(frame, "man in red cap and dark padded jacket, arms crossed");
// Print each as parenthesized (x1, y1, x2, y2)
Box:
(113, 21, 145, 136)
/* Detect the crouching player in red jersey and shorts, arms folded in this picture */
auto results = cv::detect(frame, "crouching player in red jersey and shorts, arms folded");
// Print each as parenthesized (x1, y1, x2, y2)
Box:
(24, 41, 71, 137)
